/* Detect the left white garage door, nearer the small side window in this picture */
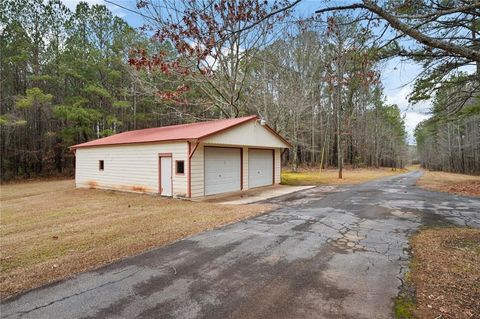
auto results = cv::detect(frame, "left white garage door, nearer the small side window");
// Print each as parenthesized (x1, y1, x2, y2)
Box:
(205, 147, 241, 195)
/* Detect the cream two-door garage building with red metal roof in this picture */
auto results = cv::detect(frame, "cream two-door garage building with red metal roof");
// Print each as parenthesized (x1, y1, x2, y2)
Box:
(71, 116, 290, 197)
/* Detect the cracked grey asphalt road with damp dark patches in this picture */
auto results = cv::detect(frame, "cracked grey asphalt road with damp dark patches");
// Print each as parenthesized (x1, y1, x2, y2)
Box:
(1, 172, 480, 319)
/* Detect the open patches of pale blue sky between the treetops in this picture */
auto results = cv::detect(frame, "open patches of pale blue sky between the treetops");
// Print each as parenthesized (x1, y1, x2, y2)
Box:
(63, 0, 430, 144)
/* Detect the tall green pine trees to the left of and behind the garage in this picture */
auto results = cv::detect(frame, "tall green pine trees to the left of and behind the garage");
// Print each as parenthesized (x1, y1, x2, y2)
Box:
(0, 1, 172, 180)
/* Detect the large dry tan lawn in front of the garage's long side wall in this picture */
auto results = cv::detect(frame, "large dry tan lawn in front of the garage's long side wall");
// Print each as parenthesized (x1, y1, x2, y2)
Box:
(0, 180, 269, 298)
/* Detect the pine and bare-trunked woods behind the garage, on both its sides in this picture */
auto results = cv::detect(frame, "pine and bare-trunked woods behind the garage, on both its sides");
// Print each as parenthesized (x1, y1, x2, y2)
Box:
(0, 1, 406, 180)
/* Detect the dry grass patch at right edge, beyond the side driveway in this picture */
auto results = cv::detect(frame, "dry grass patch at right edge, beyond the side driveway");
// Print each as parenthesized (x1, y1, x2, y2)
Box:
(417, 171, 480, 196)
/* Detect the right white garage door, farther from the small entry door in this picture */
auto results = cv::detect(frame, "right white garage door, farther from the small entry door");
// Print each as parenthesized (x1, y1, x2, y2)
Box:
(248, 149, 273, 188)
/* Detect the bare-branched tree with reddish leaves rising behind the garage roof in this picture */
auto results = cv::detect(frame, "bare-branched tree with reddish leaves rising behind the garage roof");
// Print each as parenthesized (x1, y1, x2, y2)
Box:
(130, 0, 298, 117)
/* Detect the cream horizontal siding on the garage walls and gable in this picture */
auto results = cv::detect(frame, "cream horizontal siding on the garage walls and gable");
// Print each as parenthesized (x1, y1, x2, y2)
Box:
(75, 121, 288, 197)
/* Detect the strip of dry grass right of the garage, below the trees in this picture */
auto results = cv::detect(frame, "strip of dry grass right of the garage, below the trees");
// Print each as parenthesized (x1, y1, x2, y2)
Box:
(282, 167, 408, 185)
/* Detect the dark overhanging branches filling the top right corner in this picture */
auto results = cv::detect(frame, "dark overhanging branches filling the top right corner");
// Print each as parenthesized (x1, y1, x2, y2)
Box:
(316, 0, 480, 113)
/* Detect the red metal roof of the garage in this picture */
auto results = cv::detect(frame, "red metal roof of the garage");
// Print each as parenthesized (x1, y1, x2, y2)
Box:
(70, 115, 289, 149)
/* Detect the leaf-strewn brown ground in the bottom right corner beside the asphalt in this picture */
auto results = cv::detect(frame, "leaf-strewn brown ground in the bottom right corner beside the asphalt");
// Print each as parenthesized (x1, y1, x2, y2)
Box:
(410, 228, 480, 319)
